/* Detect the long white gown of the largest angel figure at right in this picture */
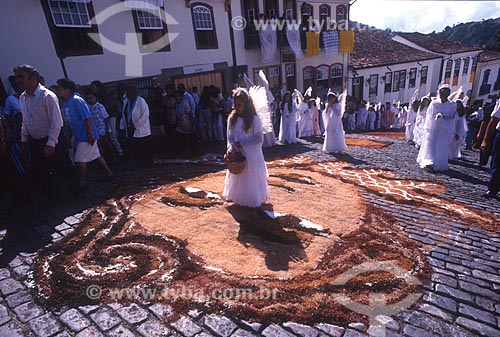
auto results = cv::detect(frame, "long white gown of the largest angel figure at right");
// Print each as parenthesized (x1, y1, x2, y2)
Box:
(417, 99, 456, 171)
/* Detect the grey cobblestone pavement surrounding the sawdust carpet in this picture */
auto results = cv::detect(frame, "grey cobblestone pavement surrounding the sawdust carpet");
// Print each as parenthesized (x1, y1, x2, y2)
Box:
(0, 135, 500, 337)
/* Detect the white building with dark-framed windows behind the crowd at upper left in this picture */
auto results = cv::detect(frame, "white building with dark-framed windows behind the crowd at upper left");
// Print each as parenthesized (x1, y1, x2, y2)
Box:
(0, 0, 238, 96)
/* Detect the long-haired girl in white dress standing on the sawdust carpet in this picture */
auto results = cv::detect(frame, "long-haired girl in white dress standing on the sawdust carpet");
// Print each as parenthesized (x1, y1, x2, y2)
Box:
(222, 88, 270, 207)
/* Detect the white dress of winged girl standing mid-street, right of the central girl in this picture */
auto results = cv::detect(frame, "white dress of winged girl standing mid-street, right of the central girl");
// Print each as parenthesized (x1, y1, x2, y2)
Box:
(323, 103, 347, 153)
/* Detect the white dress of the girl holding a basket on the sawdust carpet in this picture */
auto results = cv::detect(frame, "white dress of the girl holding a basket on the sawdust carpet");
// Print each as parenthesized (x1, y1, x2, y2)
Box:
(222, 116, 270, 207)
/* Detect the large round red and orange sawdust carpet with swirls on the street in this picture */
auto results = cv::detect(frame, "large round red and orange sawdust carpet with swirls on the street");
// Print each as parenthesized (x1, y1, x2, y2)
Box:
(33, 156, 493, 324)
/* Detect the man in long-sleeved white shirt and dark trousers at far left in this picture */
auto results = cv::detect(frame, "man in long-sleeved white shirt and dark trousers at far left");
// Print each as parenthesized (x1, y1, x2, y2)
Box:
(14, 65, 76, 203)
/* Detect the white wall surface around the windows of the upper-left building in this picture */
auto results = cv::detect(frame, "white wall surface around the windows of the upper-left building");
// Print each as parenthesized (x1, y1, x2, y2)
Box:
(0, 0, 232, 88)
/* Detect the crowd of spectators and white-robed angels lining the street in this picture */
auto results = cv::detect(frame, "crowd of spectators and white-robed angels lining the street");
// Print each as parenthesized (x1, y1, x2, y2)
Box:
(0, 65, 500, 207)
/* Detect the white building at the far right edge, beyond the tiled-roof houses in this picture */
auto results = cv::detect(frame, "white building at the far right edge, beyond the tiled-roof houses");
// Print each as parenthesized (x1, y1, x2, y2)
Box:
(472, 50, 500, 102)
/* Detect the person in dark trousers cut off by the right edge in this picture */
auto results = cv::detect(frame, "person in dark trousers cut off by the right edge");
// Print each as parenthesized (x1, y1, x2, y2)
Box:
(481, 99, 500, 198)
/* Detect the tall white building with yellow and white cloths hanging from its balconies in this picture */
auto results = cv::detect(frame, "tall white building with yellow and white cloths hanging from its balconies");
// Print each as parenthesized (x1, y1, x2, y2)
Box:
(232, 0, 352, 94)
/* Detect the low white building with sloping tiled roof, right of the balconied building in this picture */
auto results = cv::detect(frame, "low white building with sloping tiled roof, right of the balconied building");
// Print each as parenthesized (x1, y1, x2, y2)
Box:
(348, 30, 441, 103)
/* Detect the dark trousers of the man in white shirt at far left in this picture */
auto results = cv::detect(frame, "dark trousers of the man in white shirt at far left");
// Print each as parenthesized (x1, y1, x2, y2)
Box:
(30, 136, 77, 200)
